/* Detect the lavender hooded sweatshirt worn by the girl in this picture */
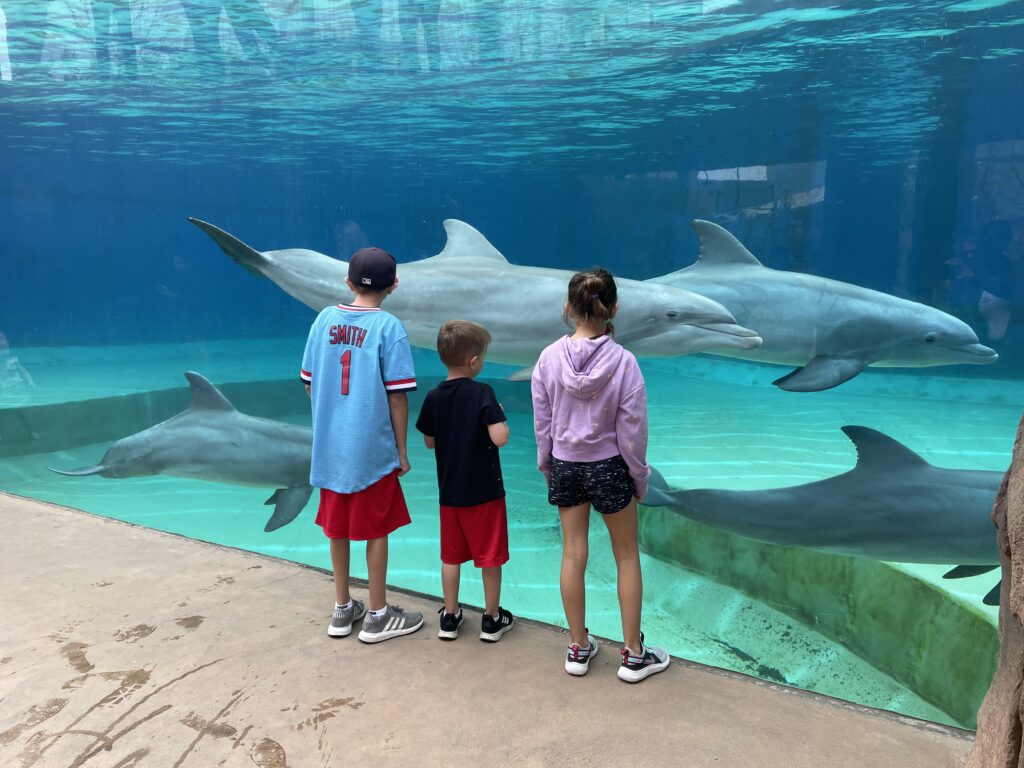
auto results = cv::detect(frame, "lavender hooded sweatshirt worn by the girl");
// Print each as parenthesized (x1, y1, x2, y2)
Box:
(532, 336, 650, 498)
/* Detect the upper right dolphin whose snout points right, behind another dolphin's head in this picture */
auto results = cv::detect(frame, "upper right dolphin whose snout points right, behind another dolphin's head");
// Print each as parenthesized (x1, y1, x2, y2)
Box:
(647, 219, 998, 392)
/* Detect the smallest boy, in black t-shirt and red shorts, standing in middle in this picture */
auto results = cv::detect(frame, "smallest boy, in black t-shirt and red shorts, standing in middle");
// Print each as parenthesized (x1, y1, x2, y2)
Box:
(416, 321, 513, 643)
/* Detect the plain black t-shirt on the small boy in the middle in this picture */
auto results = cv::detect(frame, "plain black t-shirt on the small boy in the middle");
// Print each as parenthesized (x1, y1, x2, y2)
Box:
(416, 379, 506, 507)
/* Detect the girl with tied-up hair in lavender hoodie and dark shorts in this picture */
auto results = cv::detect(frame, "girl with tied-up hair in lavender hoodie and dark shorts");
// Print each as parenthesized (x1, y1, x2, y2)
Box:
(532, 269, 669, 683)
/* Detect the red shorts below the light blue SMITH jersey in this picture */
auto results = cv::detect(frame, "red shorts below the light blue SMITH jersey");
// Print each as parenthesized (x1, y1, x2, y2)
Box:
(316, 469, 412, 542)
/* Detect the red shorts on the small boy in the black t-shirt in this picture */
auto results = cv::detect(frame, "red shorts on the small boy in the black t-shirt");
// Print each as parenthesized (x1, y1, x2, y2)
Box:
(441, 497, 509, 568)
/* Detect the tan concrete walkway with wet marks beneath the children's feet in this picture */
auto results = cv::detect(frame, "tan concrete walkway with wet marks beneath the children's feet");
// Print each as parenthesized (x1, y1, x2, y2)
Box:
(0, 495, 971, 768)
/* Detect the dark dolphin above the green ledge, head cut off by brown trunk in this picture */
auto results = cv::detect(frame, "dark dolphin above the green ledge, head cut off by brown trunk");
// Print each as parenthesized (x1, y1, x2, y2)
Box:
(643, 426, 1002, 578)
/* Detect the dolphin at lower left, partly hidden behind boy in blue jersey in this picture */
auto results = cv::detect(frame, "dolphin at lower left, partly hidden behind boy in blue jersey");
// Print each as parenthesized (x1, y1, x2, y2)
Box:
(49, 371, 312, 532)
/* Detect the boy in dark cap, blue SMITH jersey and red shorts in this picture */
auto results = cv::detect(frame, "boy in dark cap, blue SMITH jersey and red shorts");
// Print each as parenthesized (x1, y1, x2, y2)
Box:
(301, 248, 423, 643)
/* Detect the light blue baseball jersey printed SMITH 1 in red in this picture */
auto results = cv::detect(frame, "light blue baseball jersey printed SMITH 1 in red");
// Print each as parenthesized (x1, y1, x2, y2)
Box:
(301, 304, 416, 494)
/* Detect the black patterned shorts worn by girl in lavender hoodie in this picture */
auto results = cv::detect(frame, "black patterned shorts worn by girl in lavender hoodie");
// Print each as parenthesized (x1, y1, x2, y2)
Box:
(548, 456, 636, 515)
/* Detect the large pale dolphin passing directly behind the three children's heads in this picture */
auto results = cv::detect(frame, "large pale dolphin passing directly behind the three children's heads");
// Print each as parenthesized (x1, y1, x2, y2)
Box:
(188, 218, 761, 378)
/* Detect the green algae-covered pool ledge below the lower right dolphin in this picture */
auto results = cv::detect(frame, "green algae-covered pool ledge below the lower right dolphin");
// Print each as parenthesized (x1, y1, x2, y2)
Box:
(640, 507, 999, 729)
